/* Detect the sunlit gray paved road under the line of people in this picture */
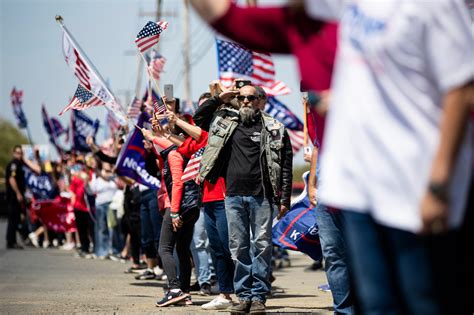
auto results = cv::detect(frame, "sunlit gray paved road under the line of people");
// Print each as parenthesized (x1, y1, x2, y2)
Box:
(0, 220, 332, 314)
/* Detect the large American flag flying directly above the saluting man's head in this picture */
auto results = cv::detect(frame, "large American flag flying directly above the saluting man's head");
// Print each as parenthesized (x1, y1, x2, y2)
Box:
(216, 38, 291, 95)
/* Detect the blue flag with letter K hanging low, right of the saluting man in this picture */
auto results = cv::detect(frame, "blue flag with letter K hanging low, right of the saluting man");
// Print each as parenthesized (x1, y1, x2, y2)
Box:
(272, 172, 323, 260)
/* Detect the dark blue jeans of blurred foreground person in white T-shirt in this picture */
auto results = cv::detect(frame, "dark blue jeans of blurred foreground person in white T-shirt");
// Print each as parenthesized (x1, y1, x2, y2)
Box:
(345, 211, 460, 315)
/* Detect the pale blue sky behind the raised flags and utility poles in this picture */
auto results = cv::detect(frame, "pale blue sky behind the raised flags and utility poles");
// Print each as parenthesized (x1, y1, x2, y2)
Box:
(0, 0, 303, 162)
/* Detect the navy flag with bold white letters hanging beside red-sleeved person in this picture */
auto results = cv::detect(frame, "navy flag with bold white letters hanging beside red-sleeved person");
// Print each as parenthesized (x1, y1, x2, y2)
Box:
(115, 112, 160, 189)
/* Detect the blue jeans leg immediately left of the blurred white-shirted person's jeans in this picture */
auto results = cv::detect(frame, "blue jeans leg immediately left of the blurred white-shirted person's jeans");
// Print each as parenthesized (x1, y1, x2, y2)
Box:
(316, 204, 354, 314)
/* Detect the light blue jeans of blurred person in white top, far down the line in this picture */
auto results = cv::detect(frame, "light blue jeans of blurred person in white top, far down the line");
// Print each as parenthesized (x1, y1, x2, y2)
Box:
(94, 202, 110, 257)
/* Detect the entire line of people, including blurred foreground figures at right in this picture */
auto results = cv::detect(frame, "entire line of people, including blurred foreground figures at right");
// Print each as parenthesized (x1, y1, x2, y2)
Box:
(3, 0, 474, 314)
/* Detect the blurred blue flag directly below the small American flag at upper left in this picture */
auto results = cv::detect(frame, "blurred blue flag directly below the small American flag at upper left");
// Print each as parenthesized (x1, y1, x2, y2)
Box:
(71, 110, 99, 152)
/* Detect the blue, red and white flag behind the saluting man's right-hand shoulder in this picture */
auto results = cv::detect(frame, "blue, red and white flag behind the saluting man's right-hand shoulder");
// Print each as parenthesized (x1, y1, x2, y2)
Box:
(265, 97, 304, 153)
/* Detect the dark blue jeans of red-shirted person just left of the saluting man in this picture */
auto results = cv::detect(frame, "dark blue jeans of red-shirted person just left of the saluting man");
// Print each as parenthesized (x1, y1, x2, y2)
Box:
(204, 201, 235, 293)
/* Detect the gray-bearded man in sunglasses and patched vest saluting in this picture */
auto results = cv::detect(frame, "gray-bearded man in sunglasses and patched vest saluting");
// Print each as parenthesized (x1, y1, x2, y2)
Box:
(195, 86, 293, 314)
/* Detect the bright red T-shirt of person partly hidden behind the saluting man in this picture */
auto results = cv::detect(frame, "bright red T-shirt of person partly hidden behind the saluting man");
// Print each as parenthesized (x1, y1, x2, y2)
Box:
(176, 130, 225, 202)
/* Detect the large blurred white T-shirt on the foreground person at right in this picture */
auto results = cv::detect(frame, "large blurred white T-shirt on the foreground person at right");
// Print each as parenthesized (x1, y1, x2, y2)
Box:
(306, 0, 474, 232)
